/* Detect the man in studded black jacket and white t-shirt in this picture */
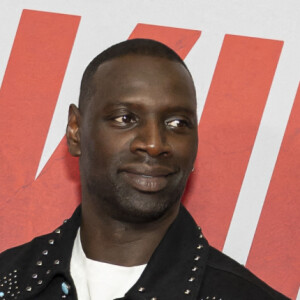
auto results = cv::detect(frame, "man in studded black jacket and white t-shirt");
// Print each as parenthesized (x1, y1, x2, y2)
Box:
(0, 39, 287, 300)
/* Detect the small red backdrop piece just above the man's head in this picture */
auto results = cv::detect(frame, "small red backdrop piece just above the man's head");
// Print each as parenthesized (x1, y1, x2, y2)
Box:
(129, 24, 201, 59)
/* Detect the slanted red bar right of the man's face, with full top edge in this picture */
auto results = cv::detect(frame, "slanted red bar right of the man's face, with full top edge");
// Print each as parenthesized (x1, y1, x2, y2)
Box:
(185, 35, 283, 249)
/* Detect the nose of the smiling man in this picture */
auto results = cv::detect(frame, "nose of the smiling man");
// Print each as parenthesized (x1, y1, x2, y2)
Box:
(130, 121, 172, 157)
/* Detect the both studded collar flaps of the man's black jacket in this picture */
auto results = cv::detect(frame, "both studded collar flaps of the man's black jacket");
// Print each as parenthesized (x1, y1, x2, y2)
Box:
(15, 206, 209, 300)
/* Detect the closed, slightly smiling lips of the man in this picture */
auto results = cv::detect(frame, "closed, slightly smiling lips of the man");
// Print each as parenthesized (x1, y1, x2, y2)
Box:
(120, 165, 175, 193)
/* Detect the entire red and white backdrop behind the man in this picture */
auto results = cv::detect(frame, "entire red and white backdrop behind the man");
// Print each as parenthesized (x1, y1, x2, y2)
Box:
(0, 0, 300, 299)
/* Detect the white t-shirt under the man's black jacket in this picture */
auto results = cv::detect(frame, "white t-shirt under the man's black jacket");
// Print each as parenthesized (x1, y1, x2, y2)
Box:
(71, 230, 146, 300)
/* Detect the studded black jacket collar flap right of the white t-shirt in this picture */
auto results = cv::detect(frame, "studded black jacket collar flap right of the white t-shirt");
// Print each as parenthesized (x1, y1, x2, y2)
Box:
(126, 206, 209, 300)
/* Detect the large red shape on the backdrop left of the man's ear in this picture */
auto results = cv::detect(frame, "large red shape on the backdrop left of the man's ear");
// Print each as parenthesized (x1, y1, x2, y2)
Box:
(0, 10, 80, 251)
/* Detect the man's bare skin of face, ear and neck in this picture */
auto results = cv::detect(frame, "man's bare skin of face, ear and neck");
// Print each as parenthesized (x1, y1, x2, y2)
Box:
(67, 55, 198, 266)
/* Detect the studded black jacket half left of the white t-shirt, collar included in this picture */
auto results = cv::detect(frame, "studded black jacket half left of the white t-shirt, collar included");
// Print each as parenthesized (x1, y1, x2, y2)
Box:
(0, 206, 80, 300)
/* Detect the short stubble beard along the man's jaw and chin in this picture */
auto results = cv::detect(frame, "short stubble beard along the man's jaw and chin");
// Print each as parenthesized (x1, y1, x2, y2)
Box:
(87, 170, 188, 223)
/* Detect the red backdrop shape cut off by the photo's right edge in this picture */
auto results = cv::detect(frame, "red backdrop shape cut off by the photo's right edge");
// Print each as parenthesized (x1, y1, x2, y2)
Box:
(247, 86, 300, 299)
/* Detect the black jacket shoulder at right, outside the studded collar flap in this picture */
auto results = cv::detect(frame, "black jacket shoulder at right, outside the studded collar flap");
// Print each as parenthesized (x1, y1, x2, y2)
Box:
(202, 247, 288, 300)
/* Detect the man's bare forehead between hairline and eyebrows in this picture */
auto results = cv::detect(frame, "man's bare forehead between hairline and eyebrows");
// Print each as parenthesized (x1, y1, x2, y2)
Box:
(92, 55, 196, 111)
